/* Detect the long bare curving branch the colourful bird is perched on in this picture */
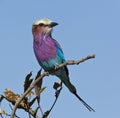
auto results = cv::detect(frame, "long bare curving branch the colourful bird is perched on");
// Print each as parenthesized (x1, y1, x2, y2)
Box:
(10, 55, 95, 118)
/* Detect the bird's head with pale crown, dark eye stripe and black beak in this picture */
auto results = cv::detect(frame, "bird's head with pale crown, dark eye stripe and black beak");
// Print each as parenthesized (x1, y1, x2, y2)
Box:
(32, 18, 58, 35)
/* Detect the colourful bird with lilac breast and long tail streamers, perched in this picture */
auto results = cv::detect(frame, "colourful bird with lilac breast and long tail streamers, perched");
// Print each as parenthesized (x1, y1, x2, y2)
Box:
(32, 18, 95, 111)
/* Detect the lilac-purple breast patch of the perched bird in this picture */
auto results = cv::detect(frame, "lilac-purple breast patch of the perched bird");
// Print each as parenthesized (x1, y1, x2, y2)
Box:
(34, 36, 56, 62)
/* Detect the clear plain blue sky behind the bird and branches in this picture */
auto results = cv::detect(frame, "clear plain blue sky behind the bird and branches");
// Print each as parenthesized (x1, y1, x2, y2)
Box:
(0, 0, 120, 118)
